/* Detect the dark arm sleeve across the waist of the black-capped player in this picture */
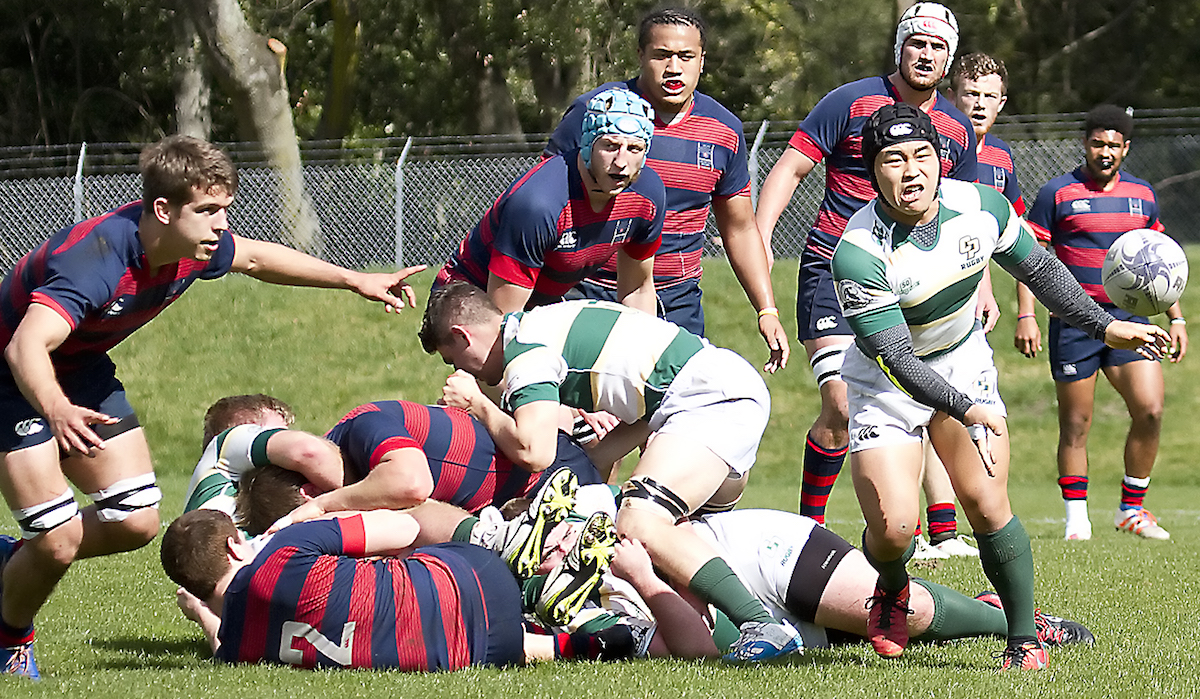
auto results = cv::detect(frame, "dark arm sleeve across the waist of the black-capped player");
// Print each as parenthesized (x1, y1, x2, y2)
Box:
(857, 325, 973, 423)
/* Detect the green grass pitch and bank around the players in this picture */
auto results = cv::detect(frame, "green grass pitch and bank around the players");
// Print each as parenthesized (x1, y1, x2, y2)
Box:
(0, 259, 1200, 699)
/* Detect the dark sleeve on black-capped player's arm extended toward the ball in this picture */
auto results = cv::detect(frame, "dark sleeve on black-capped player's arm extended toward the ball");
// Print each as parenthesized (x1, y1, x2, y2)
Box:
(996, 245, 1115, 340)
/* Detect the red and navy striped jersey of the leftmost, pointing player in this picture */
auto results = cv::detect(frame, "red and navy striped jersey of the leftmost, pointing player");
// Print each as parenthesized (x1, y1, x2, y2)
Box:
(0, 202, 234, 376)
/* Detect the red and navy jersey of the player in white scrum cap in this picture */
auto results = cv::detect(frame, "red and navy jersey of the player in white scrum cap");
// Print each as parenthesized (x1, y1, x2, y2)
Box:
(787, 76, 978, 259)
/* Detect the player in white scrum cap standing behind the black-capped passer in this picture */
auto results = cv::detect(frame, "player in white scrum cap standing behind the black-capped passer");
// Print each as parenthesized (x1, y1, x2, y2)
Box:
(755, 2, 984, 522)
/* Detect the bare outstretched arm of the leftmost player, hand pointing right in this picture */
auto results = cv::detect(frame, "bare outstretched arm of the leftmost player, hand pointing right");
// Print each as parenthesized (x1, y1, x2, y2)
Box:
(230, 235, 425, 311)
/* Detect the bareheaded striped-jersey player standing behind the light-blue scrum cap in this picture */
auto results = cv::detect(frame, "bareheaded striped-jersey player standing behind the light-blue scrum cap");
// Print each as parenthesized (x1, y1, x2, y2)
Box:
(544, 7, 790, 372)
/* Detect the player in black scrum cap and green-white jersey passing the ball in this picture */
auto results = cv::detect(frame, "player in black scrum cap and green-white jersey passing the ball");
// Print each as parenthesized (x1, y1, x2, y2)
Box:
(833, 104, 1169, 669)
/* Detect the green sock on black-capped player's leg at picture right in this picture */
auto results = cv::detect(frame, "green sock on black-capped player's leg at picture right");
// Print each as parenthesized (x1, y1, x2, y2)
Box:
(974, 515, 1038, 638)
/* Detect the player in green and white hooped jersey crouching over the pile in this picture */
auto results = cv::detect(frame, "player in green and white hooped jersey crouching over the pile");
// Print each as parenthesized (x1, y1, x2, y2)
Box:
(420, 283, 799, 659)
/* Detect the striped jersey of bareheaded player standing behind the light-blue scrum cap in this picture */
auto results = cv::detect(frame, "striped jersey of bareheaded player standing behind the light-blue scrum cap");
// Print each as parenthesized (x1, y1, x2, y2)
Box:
(546, 78, 750, 288)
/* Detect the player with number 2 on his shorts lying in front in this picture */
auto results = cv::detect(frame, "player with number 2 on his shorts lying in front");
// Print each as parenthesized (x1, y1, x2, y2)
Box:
(162, 509, 632, 671)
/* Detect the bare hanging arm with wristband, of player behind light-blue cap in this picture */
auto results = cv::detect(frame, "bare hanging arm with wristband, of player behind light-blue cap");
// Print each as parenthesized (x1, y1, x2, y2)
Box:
(713, 197, 791, 374)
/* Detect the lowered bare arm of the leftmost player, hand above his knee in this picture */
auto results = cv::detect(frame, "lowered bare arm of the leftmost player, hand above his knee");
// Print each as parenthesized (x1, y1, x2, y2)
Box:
(4, 304, 118, 454)
